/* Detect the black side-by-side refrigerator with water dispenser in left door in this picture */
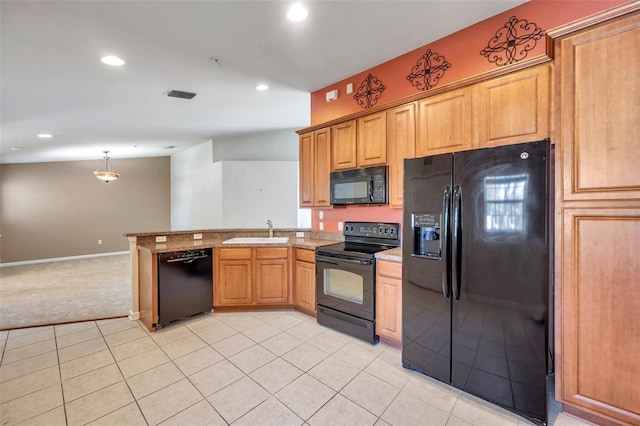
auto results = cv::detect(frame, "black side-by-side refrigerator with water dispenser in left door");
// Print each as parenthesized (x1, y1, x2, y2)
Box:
(402, 139, 550, 424)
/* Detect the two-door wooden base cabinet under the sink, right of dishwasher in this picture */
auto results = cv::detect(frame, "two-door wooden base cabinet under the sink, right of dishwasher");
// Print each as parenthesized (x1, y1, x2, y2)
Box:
(218, 247, 292, 308)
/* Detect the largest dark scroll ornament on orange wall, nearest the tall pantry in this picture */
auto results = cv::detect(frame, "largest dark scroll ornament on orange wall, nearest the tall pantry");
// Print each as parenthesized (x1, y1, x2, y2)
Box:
(480, 16, 544, 66)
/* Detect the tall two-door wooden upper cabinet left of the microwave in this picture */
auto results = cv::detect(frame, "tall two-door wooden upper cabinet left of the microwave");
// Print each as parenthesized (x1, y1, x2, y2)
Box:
(299, 127, 331, 207)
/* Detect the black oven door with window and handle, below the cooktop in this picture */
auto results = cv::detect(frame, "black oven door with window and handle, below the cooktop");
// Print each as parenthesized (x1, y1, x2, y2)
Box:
(316, 254, 375, 321)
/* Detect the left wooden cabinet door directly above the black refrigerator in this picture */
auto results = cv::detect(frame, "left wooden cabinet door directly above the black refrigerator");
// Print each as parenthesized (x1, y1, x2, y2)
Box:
(416, 87, 474, 157)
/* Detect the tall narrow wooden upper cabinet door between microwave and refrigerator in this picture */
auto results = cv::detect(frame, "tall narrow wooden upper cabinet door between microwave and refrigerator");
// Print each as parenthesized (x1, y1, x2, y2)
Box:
(387, 102, 416, 207)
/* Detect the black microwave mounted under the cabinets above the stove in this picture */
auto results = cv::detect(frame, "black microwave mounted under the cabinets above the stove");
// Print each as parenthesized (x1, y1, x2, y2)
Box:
(330, 166, 388, 205)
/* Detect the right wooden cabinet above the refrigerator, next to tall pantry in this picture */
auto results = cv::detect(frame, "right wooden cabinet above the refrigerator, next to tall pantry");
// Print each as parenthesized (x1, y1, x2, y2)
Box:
(477, 64, 552, 148)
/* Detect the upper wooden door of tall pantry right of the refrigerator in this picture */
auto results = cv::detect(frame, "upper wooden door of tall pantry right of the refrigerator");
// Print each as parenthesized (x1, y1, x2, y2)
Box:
(556, 13, 640, 201)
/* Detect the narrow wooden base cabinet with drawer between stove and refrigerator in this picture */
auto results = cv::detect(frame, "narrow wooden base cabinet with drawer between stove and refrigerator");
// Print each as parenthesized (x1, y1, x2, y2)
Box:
(376, 260, 402, 345)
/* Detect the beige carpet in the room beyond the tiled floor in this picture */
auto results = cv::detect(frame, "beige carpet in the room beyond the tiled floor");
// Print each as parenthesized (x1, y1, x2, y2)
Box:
(0, 254, 131, 330)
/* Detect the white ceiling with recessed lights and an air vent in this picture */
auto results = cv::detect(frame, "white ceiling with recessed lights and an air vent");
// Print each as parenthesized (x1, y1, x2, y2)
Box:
(0, 0, 524, 163)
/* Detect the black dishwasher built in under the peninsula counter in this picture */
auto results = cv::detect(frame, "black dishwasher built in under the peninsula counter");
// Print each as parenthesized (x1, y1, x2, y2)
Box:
(156, 248, 213, 328)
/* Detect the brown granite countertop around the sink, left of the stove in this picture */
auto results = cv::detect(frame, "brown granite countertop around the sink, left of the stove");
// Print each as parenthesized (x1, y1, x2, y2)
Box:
(138, 237, 336, 254)
